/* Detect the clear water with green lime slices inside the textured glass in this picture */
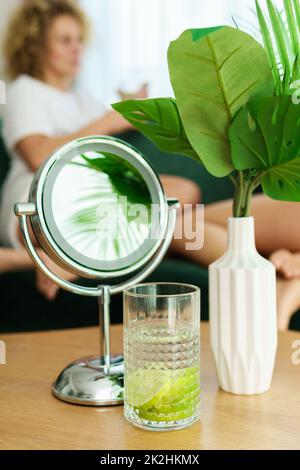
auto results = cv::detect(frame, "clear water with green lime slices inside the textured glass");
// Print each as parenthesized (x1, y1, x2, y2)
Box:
(124, 319, 200, 430)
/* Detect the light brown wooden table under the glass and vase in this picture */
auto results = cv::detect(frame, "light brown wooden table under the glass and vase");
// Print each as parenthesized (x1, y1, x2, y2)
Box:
(0, 324, 300, 450)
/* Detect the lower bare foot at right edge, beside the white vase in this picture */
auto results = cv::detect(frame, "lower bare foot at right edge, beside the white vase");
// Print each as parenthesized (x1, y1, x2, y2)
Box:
(277, 279, 300, 331)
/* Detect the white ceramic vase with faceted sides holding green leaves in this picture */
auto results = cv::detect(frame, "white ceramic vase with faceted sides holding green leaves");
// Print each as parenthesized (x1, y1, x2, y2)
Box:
(209, 217, 277, 395)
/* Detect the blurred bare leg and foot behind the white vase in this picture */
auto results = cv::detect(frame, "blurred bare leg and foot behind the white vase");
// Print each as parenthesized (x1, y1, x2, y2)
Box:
(172, 195, 300, 330)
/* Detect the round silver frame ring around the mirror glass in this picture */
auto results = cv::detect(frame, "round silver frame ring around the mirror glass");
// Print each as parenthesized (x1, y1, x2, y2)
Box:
(29, 136, 168, 279)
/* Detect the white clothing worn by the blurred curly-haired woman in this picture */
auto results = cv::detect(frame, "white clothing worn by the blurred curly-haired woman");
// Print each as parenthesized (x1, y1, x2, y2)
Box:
(0, 75, 106, 248)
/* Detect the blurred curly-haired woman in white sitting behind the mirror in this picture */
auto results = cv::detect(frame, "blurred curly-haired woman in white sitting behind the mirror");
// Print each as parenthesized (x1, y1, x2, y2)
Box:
(0, 0, 200, 298)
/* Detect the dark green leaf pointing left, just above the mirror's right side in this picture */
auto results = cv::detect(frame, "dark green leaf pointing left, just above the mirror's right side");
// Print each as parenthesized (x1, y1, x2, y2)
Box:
(112, 98, 200, 162)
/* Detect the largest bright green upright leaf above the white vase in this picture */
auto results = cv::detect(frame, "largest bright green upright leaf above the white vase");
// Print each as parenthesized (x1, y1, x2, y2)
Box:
(168, 27, 272, 177)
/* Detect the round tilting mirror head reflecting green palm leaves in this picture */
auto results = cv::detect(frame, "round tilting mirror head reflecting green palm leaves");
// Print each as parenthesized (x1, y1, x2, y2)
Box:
(29, 137, 167, 278)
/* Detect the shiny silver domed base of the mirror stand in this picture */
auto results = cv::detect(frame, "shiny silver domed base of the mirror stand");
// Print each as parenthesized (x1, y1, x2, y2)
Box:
(52, 356, 124, 406)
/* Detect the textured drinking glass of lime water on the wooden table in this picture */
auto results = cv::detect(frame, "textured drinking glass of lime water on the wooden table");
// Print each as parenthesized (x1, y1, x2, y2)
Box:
(124, 283, 200, 431)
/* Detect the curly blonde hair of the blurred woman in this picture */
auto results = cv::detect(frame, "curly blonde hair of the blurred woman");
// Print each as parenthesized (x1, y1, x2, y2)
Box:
(3, 0, 88, 79)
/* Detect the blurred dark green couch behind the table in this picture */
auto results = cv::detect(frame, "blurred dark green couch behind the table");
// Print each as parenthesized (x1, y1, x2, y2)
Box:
(0, 126, 300, 333)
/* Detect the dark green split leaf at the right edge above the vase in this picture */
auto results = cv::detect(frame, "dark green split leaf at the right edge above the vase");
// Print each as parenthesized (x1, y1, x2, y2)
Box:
(229, 96, 300, 201)
